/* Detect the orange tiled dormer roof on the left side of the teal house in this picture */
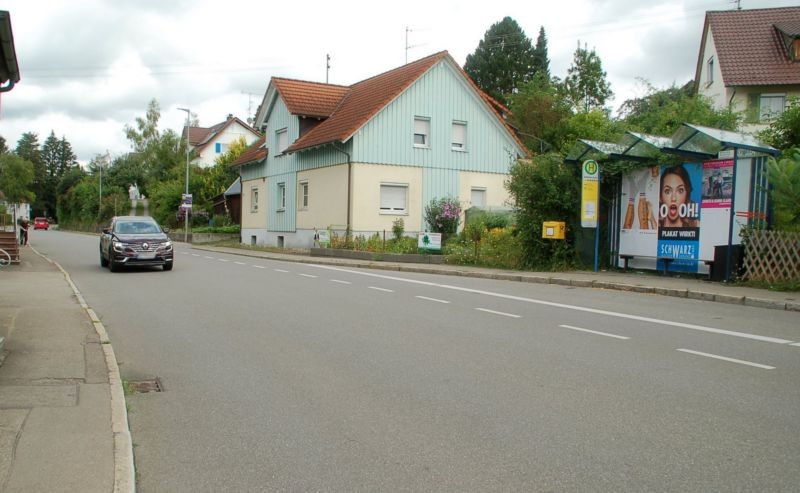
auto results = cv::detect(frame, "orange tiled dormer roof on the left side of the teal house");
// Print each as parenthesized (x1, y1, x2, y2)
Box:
(272, 77, 350, 118)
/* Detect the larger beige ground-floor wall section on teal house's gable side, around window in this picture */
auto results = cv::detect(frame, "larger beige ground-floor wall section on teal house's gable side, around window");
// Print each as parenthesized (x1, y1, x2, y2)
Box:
(352, 163, 422, 231)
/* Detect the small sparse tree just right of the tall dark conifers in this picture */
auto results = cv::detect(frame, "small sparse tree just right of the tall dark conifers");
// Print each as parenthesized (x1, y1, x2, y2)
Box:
(564, 41, 614, 112)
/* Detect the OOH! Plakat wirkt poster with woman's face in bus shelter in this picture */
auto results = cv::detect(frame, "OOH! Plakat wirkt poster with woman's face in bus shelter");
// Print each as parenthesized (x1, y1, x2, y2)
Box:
(657, 163, 703, 272)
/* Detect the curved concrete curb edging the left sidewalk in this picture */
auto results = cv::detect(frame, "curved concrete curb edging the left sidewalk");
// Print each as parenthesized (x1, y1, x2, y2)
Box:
(30, 246, 136, 493)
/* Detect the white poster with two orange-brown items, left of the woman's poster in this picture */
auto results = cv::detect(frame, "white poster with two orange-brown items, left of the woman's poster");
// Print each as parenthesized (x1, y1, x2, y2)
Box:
(619, 166, 661, 260)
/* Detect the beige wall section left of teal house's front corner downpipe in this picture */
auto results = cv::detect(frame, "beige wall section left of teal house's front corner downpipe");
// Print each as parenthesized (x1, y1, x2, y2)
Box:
(296, 164, 347, 229)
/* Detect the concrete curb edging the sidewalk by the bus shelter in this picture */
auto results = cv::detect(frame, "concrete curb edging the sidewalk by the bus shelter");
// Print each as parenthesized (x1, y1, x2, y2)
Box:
(194, 245, 800, 312)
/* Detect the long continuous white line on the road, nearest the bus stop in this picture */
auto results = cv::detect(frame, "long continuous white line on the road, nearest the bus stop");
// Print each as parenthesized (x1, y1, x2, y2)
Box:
(308, 264, 795, 344)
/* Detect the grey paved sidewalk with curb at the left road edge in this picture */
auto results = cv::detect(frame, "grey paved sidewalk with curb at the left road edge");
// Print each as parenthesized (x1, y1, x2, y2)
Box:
(0, 246, 135, 493)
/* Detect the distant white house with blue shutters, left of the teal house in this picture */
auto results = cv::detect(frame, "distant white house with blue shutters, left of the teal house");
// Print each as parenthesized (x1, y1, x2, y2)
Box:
(183, 115, 260, 168)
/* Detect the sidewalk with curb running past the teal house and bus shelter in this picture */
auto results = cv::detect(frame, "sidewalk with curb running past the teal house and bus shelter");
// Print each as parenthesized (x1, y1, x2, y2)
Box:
(192, 245, 800, 312)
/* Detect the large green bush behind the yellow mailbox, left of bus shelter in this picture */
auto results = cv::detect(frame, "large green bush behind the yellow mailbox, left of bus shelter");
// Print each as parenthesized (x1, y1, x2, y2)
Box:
(506, 153, 580, 270)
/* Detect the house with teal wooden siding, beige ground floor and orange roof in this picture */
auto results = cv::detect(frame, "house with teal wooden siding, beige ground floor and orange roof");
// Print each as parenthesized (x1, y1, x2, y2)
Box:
(235, 51, 527, 248)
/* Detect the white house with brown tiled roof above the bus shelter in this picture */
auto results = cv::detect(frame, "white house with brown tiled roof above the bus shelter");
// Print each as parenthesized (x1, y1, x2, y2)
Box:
(694, 7, 800, 133)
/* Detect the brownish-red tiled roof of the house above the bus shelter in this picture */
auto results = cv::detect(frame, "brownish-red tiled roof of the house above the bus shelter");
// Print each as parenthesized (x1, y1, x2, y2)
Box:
(698, 7, 800, 86)
